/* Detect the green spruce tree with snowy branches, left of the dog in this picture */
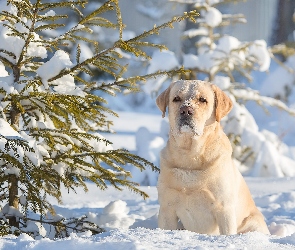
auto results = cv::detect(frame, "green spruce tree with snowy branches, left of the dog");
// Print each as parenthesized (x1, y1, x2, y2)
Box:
(0, 0, 196, 237)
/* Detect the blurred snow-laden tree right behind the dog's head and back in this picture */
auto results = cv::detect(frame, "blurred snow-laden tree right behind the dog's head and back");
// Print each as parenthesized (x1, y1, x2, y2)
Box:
(165, 0, 295, 176)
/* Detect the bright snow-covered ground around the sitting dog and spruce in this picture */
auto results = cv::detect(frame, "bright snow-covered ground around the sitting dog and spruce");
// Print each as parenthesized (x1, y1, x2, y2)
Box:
(0, 112, 295, 250)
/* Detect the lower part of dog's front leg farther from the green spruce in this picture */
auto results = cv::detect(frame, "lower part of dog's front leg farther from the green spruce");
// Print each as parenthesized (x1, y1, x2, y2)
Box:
(216, 208, 237, 235)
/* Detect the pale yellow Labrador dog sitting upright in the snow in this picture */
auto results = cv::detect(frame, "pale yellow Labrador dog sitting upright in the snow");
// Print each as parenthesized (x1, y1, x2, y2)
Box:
(156, 80, 269, 235)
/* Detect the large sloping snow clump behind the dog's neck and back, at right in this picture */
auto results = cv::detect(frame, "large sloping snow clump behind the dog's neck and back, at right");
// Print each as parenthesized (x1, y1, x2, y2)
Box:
(223, 98, 295, 177)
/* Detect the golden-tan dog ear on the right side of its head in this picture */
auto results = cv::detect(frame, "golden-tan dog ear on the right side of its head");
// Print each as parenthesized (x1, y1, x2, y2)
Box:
(211, 84, 233, 122)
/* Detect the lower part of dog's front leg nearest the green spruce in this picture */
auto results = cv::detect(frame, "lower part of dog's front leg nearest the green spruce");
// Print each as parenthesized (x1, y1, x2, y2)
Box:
(158, 205, 178, 230)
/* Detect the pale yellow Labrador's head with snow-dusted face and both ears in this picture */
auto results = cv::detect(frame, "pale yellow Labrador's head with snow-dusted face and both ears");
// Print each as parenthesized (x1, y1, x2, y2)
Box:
(156, 80, 232, 136)
